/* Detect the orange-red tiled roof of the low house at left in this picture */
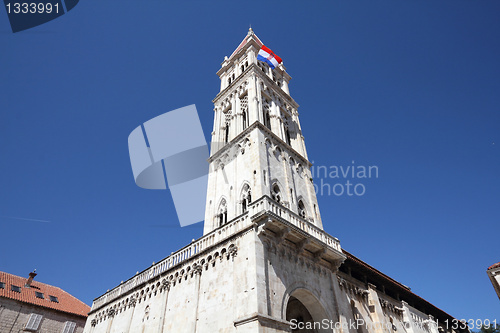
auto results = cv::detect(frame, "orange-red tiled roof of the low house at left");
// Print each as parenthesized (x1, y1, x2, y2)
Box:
(0, 272, 90, 317)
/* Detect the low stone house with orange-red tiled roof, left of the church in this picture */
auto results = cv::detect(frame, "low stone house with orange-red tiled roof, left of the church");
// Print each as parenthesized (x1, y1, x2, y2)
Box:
(0, 272, 90, 333)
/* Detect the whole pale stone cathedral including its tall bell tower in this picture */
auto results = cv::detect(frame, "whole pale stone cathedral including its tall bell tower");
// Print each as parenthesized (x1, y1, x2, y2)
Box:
(84, 29, 462, 333)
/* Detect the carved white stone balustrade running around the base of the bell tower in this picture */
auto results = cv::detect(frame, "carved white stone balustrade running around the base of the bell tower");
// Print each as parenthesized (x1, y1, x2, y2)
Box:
(91, 196, 341, 312)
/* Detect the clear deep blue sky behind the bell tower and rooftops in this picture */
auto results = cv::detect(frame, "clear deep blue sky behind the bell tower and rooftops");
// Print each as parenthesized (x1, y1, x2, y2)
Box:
(0, 0, 500, 319)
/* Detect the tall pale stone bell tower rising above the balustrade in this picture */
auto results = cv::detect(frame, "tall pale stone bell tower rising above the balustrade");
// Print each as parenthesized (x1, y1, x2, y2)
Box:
(204, 29, 323, 234)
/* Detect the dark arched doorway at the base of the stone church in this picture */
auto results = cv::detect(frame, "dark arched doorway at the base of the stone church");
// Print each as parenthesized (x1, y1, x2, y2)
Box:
(285, 289, 331, 333)
